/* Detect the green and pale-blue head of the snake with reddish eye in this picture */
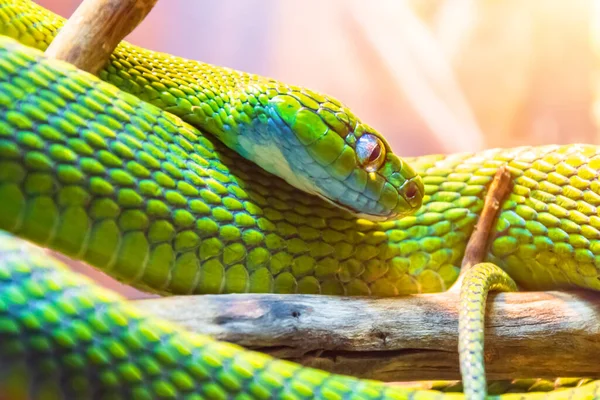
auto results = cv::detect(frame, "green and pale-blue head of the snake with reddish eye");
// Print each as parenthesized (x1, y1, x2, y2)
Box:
(266, 87, 424, 220)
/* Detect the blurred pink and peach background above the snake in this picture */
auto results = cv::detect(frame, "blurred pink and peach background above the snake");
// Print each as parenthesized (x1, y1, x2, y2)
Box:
(37, 0, 600, 296)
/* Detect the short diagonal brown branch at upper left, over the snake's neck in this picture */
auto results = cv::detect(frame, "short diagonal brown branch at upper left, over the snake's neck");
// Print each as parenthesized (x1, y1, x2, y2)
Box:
(46, 0, 158, 74)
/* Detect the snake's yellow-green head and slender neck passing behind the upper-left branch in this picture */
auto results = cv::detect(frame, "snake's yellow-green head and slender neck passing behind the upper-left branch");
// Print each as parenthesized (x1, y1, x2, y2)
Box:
(0, 0, 421, 222)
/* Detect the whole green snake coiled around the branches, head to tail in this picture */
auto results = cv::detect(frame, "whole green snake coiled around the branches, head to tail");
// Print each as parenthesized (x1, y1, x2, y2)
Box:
(0, 0, 600, 399)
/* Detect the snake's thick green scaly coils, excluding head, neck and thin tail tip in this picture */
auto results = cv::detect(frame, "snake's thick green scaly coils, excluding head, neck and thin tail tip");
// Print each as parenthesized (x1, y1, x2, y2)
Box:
(0, 1, 600, 398)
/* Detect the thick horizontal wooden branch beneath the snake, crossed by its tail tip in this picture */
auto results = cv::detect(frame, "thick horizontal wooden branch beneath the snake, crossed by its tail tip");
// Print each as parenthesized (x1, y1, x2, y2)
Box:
(136, 291, 600, 381)
